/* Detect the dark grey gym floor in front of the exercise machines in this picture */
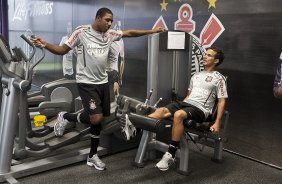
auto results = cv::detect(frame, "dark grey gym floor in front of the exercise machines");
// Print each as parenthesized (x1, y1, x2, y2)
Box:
(18, 144, 282, 184)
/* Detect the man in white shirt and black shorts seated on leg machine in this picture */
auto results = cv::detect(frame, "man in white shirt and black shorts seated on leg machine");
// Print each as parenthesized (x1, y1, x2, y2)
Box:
(149, 47, 228, 171)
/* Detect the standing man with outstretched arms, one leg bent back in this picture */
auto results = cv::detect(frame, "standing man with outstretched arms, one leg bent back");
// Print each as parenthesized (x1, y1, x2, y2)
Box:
(33, 8, 164, 170)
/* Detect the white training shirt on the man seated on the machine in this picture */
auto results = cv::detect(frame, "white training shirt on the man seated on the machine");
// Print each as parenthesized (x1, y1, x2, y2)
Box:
(184, 71, 228, 118)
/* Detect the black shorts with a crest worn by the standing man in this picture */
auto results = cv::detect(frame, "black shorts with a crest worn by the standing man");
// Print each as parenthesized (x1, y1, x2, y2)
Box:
(77, 83, 111, 116)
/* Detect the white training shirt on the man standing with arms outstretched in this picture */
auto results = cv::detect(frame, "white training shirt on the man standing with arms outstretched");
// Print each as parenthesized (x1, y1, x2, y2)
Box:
(65, 24, 122, 84)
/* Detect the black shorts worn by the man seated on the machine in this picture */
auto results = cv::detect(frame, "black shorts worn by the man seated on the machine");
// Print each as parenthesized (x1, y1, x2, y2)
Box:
(165, 101, 206, 123)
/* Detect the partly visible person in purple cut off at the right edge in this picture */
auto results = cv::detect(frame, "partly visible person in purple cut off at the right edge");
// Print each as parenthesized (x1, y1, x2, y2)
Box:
(273, 53, 282, 99)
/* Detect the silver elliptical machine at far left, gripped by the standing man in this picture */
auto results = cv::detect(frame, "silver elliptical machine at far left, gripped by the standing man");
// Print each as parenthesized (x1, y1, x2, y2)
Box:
(0, 35, 92, 183)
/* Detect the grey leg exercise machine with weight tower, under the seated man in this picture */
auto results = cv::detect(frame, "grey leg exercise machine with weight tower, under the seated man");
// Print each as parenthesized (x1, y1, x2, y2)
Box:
(115, 33, 229, 175)
